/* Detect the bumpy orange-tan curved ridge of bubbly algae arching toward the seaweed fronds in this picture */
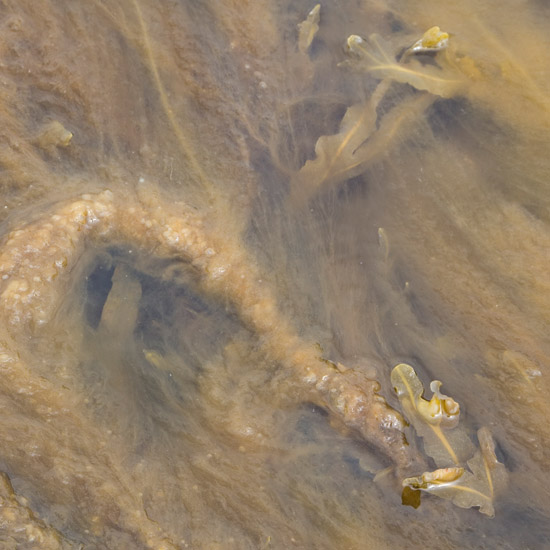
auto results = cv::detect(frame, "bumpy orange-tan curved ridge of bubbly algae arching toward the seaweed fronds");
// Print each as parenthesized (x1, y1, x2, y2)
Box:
(0, 191, 411, 474)
